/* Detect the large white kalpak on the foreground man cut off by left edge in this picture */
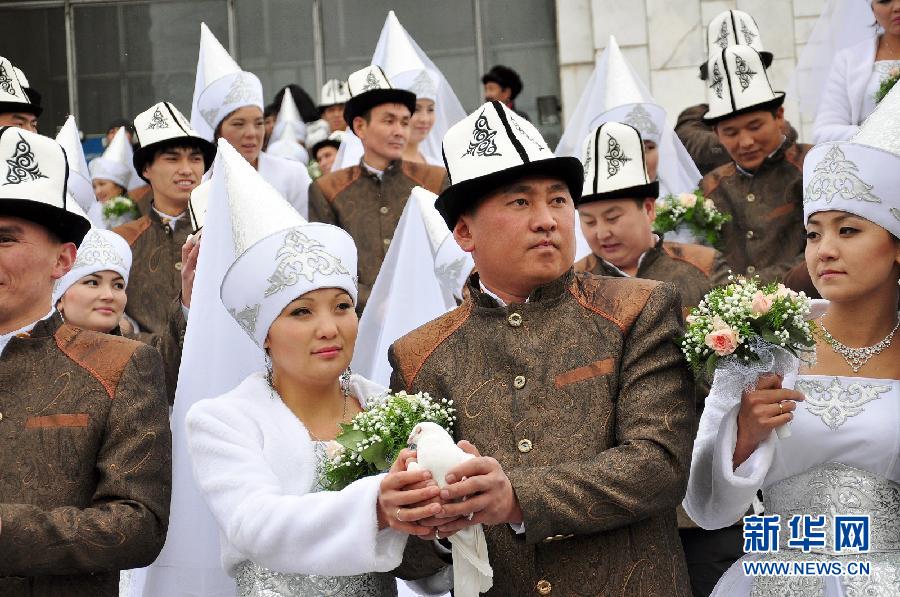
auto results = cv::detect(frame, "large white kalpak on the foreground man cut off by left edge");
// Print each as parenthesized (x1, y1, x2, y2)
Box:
(0, 126, 91, 245)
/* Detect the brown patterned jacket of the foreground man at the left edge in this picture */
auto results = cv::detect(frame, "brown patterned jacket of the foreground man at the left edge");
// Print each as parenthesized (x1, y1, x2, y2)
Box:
(0, 314, 172, 597)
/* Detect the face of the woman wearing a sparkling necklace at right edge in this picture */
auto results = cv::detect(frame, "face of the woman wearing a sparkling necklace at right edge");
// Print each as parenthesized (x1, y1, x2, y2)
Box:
(806, 211, 900, 302)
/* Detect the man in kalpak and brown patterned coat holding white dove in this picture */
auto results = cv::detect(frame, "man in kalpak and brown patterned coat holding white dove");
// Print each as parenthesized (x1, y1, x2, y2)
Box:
(390, 102, 694, 597)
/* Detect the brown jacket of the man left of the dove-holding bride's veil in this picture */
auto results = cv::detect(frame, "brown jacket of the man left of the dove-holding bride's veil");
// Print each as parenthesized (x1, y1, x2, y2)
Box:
(113, 209, 191, 344)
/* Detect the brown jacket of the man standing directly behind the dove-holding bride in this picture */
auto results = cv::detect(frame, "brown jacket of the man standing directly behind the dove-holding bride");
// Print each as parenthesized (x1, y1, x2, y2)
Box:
(309, 160, 449, 313)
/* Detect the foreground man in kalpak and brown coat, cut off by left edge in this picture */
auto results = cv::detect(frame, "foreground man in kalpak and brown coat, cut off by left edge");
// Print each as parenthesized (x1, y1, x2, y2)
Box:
(0, 128, 171, 597)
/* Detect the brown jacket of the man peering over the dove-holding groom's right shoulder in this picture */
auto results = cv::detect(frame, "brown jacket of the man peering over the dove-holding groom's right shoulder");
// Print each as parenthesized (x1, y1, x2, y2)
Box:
(575, 241, 728, 311)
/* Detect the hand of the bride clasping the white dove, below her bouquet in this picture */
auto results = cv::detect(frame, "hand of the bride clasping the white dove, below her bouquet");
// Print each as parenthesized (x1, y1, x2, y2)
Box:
(376, 450, 441, 537)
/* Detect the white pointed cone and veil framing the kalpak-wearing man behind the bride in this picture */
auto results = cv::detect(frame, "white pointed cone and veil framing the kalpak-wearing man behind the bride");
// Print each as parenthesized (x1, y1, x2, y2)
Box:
(332, 10, 466, 171)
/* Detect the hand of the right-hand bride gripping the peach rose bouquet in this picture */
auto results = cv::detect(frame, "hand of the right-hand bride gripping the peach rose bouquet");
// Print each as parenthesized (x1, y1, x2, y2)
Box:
(732, 375, 805, 468)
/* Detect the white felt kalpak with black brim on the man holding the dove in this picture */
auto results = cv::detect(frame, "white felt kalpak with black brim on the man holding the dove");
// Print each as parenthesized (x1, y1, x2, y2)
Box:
(435, 101, 584, 230)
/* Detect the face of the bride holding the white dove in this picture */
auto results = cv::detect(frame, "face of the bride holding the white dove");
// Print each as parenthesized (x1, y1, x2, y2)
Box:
(264, 288, 359, 385)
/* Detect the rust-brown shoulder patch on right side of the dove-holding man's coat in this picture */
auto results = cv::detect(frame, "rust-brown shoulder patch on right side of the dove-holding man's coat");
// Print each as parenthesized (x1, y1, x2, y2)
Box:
(569, 273, 662, 334)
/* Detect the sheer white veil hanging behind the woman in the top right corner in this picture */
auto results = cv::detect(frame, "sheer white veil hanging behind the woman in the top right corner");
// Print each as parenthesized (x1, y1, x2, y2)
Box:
(788, 0, 881, 122)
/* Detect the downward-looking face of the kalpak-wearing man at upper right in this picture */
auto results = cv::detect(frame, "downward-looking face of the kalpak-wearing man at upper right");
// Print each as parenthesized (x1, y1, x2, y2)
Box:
(715, 108, 784, 170)
